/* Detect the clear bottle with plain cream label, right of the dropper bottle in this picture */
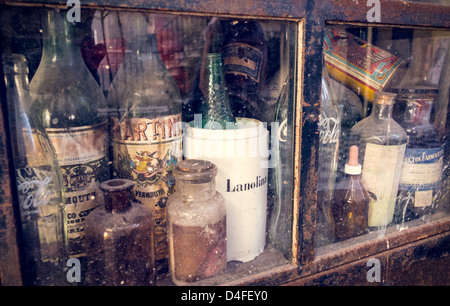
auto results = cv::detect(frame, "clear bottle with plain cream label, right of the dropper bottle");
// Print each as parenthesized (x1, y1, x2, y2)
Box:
(351, 92, 408, 229)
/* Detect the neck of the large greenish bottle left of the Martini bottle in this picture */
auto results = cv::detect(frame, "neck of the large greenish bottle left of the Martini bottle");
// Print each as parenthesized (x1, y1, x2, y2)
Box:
(42, 10, 82, 66)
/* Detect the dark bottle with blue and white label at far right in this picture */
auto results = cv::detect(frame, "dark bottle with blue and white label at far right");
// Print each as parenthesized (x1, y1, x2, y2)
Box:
(394, 86, 444, 223)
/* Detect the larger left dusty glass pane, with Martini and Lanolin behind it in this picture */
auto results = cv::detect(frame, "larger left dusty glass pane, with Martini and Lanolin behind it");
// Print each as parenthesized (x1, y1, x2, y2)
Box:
(0, 7, 301, 285)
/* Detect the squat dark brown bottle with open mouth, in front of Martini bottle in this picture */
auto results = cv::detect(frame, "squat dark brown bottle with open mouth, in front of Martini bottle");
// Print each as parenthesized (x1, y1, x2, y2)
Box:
(84, 179, 156, 286)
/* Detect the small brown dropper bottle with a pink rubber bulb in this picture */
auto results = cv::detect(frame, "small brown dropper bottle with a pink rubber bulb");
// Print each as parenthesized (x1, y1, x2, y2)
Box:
(332, 146, 370, 241)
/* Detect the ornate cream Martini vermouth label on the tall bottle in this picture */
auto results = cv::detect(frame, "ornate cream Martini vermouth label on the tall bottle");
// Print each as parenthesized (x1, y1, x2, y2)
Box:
(111, 114, 182, 260)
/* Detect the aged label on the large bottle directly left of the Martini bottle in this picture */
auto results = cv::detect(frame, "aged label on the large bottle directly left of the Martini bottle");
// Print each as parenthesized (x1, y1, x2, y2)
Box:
(47, 121, 109, 257)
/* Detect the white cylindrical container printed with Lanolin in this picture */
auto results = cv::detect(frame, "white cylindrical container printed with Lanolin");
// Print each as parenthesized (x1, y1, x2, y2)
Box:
(183, 118, 269, 262)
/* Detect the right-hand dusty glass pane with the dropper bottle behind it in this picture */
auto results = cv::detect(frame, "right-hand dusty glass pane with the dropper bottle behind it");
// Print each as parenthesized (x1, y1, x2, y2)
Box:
(316, 25, 450, 247)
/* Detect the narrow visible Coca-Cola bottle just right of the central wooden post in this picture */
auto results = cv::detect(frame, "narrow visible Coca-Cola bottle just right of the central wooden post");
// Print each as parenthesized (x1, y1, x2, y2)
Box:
(316, 64, 341, 246)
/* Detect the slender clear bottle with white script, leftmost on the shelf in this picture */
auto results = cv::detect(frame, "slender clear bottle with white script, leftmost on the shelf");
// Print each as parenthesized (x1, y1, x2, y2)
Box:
(3, 54, 67, 286)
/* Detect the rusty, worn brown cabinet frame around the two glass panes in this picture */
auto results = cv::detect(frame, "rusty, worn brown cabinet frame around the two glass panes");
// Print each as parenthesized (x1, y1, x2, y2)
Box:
(0, 0, 450, 285)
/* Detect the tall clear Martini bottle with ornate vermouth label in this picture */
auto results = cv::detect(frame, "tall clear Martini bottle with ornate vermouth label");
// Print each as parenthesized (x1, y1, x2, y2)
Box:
(107, 13, 182, 269)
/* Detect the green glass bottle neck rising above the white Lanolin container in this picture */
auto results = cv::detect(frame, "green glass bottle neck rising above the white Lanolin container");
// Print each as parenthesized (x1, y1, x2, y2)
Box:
(200, 53, 236, 129)
